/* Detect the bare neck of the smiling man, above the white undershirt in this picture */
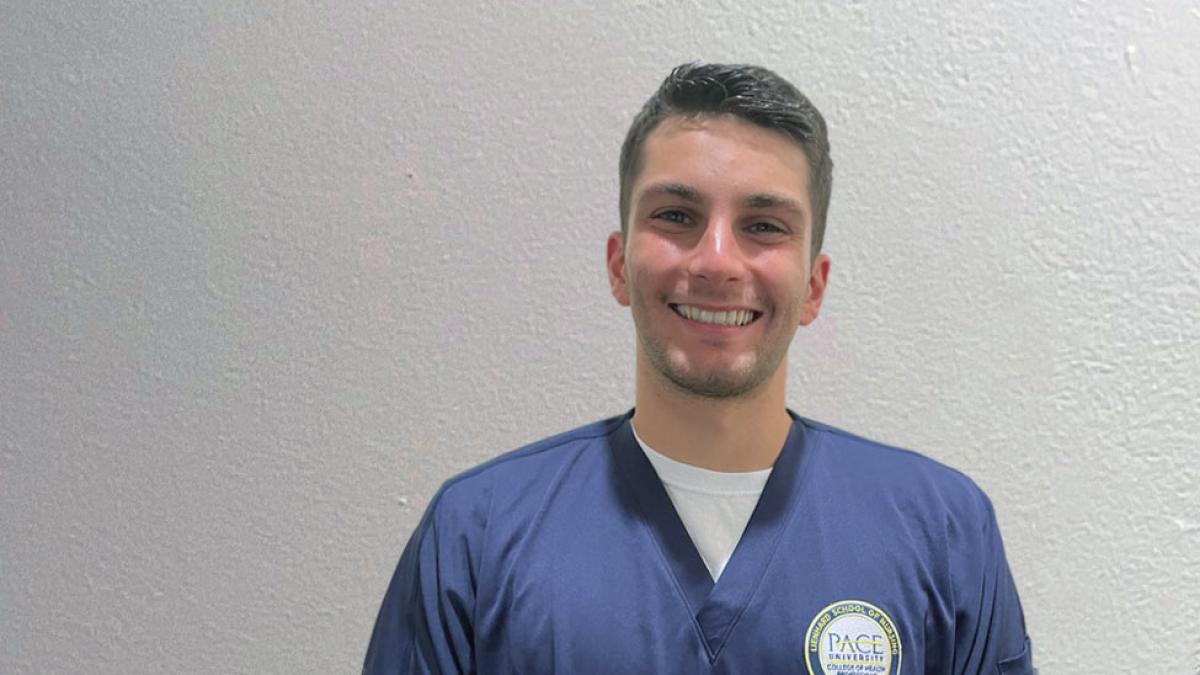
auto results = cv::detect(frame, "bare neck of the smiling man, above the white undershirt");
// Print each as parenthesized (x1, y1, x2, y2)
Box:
(634, 356, 792, 472)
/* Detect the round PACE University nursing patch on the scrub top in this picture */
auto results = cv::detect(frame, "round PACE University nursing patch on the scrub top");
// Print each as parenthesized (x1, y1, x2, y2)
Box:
(804, 601, 900, 675)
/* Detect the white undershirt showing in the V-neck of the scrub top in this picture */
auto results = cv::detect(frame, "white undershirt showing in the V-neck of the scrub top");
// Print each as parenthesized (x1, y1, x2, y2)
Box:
(634, 430, 770, 581)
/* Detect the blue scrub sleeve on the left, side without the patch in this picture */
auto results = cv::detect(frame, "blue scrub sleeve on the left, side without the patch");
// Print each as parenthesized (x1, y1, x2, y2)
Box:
(362, 494, 475, 675)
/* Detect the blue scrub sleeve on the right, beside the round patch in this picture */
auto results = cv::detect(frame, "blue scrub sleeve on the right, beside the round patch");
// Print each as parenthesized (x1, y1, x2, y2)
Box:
(950, 492, 1034, 675)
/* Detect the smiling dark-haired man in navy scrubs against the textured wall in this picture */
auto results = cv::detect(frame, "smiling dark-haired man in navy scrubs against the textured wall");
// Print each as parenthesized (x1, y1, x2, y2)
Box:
(364, 64, 1032, 675)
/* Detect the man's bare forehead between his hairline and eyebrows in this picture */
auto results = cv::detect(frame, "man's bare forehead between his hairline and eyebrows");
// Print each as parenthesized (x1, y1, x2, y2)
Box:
(631, 115, 810, 204)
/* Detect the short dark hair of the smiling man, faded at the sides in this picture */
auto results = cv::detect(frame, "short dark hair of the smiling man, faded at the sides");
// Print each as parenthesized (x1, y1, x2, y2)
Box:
(619, 64, 833, 256)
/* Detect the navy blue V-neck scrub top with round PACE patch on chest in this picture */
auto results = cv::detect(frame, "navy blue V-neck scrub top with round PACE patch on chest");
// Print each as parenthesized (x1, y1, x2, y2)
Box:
(364, 411, 1033, 675)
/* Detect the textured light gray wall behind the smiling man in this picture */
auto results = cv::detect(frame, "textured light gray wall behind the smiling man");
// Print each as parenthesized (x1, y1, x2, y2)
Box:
(0, 1, 1200, 675)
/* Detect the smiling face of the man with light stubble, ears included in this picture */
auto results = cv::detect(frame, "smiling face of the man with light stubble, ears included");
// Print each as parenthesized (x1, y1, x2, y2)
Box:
(608, 117, 829, 398)
